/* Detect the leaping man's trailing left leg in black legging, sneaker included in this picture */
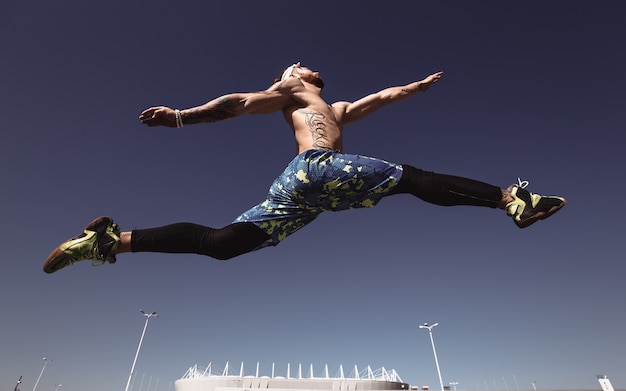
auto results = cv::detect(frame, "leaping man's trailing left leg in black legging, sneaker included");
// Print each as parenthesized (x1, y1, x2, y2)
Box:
(43, 216, 269, 273)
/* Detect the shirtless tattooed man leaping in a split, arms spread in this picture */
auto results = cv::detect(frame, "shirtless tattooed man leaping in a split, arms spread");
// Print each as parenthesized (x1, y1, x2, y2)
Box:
(43, 63, 566, 273)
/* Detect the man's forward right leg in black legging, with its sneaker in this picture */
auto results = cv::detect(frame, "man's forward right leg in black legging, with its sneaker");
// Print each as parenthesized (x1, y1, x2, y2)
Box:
(390, 165, 566, 228)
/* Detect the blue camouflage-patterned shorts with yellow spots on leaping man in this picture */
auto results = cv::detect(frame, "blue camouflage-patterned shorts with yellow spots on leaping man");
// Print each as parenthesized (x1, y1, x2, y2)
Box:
(234, 149, 402, 248)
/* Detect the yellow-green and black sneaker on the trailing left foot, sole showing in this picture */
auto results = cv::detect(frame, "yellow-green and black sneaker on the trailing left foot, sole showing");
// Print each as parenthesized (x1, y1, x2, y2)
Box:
(43, 216, 120, 273)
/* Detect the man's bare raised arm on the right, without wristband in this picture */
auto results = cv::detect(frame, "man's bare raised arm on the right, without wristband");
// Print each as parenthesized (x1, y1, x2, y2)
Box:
(333, 72, 443, 124)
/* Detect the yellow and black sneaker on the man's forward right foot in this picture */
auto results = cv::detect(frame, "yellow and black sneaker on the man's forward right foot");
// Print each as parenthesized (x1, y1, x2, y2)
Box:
(505, 178, 567, 228)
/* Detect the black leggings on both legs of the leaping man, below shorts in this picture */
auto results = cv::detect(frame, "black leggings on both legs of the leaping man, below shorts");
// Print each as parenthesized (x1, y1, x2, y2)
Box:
(131, 165, 502, 260)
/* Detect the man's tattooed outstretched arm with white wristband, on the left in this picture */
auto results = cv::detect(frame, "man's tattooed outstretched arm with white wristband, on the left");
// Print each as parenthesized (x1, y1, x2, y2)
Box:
(139, 89, 291, 127)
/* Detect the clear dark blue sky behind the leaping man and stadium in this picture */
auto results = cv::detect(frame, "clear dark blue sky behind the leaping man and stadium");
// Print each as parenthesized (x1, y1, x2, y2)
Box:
(0, 0, 626, 391)
